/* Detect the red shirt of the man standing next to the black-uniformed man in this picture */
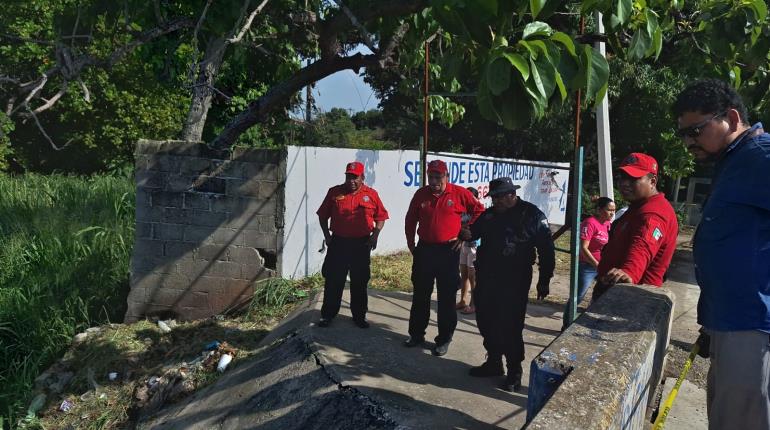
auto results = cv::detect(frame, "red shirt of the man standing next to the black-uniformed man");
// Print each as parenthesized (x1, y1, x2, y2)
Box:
(404, 184, 484, 246)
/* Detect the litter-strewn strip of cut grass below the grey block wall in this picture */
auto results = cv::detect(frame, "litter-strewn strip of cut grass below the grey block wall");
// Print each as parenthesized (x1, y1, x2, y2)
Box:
(15, 276, 321, 430)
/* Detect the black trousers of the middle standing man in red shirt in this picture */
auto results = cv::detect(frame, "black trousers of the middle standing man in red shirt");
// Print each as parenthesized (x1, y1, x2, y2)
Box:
(409, 242, 460, 345)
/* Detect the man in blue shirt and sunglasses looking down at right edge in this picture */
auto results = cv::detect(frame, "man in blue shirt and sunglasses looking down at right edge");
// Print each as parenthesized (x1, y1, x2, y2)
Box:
(673, 79, 770, 429)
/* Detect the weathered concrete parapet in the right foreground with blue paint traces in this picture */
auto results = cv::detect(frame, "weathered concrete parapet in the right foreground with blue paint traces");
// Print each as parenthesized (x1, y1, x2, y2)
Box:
(527, 285, 674, 430)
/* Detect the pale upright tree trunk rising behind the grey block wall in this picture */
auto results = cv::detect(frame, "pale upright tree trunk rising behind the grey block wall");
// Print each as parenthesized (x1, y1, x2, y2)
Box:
(180, 38, 225, 142)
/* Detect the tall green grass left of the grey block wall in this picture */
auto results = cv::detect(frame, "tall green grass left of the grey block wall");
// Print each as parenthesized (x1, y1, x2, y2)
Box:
(0, 175, 135, 424)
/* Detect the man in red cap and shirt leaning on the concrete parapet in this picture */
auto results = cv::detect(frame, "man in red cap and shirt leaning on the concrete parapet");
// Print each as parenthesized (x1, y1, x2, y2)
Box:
(593, 152, 679, 300)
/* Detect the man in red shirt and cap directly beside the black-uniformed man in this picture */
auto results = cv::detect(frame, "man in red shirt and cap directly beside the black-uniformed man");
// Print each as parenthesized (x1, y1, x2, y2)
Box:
(404, 160, 484, 356)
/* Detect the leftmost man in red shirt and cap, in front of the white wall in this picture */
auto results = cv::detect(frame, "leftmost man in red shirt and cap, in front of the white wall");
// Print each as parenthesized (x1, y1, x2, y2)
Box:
(316, 161, 388, 328)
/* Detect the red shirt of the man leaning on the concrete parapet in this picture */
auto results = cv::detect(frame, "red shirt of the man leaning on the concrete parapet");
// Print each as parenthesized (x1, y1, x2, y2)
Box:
(597, 193, 679, 287)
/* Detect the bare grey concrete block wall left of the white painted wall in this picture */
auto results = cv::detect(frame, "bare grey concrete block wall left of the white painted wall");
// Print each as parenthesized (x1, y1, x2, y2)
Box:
(125, 140, 286, 322)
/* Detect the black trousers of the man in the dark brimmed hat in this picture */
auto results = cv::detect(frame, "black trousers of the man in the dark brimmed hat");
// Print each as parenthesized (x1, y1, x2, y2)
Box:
(473, 263, 532, 372)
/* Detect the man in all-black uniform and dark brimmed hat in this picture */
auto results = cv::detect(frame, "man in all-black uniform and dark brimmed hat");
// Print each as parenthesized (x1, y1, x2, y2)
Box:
(460, 177, 556, 391)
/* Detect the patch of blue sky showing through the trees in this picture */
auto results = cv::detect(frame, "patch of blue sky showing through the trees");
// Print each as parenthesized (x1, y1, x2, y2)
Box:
(294, 45, 380, 116)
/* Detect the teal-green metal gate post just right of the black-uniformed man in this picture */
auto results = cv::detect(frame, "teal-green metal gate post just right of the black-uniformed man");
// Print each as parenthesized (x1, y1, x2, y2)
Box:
(563, 146, 583, 328)
